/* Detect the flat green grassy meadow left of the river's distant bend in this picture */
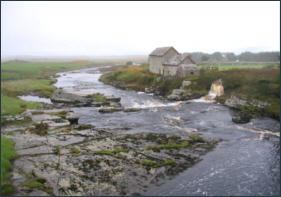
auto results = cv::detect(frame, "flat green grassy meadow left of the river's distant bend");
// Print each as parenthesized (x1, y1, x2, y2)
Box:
(1, 60, 111, 117)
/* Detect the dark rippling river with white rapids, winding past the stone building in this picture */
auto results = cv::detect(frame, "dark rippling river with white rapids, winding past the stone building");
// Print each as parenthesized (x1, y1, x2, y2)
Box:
(49, 68, 280, 196)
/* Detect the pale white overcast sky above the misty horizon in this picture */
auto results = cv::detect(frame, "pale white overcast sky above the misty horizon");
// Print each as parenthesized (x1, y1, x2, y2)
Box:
(1, 1, 280, 57)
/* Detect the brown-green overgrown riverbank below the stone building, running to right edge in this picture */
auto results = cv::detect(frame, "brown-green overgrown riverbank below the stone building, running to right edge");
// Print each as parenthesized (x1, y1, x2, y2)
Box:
(99, 65, 280, 120)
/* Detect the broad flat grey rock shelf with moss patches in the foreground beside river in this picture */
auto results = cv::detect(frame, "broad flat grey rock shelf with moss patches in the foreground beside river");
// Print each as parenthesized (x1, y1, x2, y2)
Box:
(10, 129, 218, 196)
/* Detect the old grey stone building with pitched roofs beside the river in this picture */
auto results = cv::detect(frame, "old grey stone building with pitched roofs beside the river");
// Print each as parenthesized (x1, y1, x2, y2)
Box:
(149, 47, 199, 77)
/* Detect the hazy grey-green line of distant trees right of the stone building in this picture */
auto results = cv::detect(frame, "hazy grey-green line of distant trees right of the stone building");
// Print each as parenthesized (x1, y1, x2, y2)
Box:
(183, 51, 280, 62)
